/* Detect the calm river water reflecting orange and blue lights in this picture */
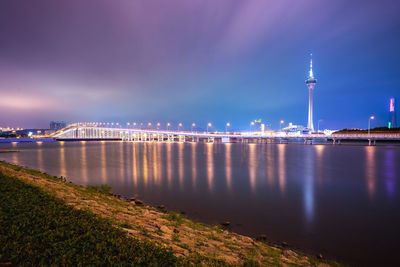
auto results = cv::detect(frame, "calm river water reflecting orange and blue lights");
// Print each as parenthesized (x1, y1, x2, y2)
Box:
(0, 142, 400, 266)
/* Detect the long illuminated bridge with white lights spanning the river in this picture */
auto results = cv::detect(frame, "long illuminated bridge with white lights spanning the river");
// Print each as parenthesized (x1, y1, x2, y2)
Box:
(52, 124, 400, 145)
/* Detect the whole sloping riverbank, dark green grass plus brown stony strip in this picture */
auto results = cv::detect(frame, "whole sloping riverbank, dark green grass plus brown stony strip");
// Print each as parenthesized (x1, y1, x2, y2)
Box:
(0, 161, 341, 267)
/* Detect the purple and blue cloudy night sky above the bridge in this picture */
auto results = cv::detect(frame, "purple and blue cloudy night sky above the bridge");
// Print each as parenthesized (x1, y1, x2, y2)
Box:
(0, 0, 400, 130)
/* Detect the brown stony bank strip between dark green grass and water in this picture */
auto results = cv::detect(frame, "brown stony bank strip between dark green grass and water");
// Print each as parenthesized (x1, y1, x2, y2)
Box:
(0, 161, 341, 267)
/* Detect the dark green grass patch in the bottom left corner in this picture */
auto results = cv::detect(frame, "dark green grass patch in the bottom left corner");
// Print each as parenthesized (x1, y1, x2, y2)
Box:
(0, 172, 180, 266)
